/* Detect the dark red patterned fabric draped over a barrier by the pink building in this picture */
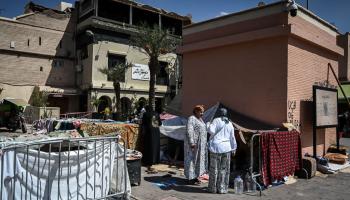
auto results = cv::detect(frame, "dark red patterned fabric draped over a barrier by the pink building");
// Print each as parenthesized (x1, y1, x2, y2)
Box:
(260, 131, 301, 186)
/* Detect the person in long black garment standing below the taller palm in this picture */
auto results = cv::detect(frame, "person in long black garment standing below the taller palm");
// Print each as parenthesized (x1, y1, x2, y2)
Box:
(141, 106, 160, 173)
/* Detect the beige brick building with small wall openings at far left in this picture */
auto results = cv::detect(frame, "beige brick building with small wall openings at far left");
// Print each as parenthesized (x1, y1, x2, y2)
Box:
(0, 3, 79, 112)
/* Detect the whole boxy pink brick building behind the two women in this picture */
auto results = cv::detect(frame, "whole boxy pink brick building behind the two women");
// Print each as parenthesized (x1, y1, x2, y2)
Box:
(180, 2, 344, 155)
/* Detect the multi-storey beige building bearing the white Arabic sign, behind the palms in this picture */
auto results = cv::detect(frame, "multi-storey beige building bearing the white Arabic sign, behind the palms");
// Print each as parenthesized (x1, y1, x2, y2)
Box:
(77, 0, 191, 113)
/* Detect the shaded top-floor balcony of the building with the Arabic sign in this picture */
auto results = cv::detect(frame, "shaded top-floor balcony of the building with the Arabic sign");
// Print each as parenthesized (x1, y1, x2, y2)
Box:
(78, 0, 191, 39)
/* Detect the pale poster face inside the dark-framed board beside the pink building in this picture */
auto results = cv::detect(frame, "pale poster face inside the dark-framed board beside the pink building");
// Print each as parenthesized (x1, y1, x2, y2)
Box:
(314, 88, 338, 127)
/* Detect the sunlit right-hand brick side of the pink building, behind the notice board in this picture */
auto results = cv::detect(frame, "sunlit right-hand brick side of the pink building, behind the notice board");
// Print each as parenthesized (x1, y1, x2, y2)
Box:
(287, 17, 339, 155)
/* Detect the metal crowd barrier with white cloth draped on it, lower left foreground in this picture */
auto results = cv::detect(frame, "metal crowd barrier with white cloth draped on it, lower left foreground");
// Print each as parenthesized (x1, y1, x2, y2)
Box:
(0, 136, 128, 200)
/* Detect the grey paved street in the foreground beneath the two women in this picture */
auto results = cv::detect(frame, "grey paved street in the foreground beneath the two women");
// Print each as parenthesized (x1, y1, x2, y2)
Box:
(132, 168, 350, 200)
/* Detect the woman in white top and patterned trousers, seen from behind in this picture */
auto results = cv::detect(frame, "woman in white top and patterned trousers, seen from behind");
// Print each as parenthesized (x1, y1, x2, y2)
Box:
(208, 108, 237, 194)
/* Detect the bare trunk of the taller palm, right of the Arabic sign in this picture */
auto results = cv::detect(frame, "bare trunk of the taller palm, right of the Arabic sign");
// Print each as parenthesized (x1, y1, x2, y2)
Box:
(148, 57, 158, 111)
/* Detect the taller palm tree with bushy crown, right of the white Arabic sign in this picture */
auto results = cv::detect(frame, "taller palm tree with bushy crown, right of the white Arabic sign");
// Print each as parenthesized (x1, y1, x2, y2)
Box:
(131, 23, 180, 111)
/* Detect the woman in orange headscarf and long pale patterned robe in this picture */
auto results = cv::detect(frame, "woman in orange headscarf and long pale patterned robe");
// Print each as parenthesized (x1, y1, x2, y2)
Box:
(184, 105, 208, 184)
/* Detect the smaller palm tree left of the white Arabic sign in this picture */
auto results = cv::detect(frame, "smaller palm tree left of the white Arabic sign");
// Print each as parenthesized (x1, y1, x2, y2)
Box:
(98, 63, 131, 113)
